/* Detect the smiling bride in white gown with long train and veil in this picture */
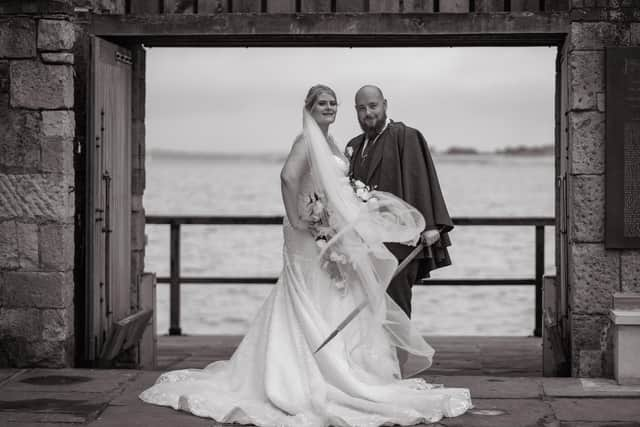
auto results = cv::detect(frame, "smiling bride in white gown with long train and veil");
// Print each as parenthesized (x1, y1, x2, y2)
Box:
(139, 85, 472, 427)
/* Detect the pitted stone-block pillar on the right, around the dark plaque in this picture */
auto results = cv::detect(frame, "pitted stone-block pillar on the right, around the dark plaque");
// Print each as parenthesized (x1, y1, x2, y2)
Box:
(565, 0, 640, 377)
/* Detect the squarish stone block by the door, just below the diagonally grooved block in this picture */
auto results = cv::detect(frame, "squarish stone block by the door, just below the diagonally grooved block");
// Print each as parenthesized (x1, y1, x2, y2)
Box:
(38, 224, 74, 271)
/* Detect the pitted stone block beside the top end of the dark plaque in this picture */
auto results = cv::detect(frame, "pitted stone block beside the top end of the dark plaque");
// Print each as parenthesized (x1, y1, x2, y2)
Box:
(568, 50, 604, 110)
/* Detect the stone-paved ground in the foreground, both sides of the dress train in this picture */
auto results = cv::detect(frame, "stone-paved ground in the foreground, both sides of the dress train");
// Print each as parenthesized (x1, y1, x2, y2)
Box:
(0, 369, 640, 427)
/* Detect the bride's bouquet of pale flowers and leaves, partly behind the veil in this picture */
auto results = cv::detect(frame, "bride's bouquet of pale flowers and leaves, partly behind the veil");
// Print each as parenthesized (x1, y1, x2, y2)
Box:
(305, 177, 377, 289)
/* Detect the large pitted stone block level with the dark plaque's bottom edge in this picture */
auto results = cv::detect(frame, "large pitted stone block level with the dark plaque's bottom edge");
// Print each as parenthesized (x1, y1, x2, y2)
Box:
(569, 243, 620, 314)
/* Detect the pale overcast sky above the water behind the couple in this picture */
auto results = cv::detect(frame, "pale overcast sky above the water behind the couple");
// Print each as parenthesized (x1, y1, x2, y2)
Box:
(146, 47, 556, 153)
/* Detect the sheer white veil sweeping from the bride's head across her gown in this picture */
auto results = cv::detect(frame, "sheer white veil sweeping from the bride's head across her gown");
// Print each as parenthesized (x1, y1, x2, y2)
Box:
(303, 109, 434, 376)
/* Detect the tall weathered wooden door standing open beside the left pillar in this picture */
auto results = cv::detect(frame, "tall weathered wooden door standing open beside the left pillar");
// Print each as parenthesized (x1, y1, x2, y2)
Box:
(85, 37, 132, 361)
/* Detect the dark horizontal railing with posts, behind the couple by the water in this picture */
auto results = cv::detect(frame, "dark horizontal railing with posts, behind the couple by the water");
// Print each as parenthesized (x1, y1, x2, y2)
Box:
(146, 215, 555, 337)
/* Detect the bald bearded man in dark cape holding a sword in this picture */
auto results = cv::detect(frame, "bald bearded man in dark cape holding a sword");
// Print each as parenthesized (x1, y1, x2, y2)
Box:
(345, 85, 453, 317)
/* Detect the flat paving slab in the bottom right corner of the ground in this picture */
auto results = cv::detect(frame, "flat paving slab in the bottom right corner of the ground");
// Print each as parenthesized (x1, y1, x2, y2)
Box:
(549, 398, 640, 422)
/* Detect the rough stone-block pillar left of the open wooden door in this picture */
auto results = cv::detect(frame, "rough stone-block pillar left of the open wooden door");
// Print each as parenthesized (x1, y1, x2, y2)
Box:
(0, 0, 75, 367)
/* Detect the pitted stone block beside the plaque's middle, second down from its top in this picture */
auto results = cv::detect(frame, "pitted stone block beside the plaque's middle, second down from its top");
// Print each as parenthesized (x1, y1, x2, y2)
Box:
(569, 111, 605, 175)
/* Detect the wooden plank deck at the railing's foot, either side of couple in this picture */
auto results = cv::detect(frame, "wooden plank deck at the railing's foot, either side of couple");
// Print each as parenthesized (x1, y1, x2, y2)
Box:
(157, 335, 542, 377)
